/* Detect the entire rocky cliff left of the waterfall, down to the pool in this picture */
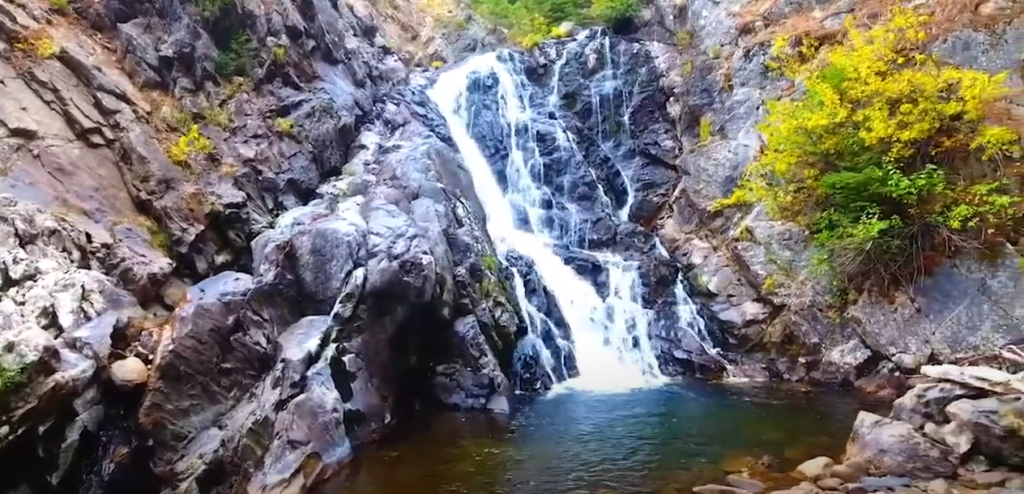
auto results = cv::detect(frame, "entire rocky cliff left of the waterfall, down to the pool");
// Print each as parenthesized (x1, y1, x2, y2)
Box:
(0, 1, 522, 492)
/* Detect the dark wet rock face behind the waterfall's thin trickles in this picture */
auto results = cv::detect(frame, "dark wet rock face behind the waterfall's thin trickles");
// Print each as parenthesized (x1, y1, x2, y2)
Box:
(456, 30, 721, 379)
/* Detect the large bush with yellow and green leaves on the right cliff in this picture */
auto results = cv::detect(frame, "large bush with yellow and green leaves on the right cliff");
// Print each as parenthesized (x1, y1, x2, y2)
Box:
(715, 8, 1024, 290)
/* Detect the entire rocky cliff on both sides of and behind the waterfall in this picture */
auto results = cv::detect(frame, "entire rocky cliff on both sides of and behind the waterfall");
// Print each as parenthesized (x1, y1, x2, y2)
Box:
(0, 0, 1024, 493)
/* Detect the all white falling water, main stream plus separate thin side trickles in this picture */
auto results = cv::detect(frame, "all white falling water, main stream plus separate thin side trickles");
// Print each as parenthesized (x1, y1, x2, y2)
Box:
(428, 39, 714, 392)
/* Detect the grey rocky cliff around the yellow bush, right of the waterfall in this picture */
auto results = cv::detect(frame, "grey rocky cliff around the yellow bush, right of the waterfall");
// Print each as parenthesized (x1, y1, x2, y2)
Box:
(639, 1, 1024, 387)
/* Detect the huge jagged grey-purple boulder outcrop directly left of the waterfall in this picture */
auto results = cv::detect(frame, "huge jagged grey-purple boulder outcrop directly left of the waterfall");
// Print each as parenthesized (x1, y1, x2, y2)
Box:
(139, 86, 520, 493)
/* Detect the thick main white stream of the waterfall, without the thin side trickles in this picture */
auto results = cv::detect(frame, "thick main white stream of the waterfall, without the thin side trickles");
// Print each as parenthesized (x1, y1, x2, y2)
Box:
(429, 53, 664, 390)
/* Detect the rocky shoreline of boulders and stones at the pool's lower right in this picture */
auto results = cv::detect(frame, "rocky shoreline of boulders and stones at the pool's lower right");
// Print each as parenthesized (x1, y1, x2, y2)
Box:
(693, 360, 1024, 494)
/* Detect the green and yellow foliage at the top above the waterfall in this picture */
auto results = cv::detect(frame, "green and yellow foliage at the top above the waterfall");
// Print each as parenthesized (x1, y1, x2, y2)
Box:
(469, 0, 641, 48)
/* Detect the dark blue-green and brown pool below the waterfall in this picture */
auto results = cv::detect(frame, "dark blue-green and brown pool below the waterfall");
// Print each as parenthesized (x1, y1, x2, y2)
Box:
(321, 381, 880, 494)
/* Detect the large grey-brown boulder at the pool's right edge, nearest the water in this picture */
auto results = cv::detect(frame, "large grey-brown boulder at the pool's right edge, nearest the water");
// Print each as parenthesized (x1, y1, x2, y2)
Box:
(846, 412, 959, 479)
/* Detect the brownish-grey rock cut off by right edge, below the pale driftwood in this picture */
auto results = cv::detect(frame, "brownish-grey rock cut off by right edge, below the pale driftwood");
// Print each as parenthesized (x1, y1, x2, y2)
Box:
(946, 395, 1024, 466)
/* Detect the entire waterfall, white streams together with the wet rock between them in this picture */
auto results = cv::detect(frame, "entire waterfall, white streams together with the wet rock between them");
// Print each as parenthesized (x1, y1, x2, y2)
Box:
(428, 32, 720, 392)
